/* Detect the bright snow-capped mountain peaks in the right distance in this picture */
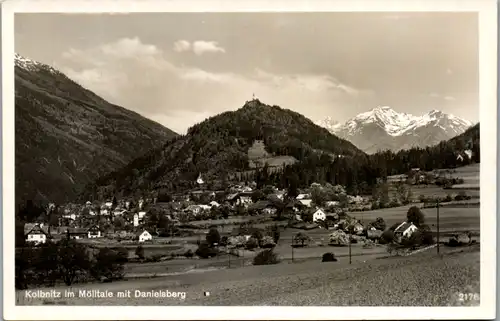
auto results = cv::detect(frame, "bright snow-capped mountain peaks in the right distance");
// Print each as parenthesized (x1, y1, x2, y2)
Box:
(317, 106, 473, 153)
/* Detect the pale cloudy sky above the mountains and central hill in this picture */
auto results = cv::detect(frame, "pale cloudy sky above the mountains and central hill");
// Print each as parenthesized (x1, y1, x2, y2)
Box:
(15, 12, 479, 133)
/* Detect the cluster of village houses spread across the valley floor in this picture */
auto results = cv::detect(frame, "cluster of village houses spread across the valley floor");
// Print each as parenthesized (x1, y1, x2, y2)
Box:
(24, 179, 415, 244)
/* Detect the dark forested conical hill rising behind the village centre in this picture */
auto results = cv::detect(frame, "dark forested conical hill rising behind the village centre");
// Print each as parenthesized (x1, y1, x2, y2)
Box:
(82, 100, 364, 198)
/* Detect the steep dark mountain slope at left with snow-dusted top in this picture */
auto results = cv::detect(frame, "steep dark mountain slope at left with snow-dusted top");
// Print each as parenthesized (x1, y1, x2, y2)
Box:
(15, 54, 177, 204)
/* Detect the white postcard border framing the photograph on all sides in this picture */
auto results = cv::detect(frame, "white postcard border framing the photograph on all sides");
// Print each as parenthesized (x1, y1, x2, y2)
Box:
(1, 0, 497, 320)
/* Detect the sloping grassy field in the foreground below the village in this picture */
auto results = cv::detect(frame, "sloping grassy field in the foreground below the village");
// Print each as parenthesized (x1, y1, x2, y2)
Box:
(16, 246, 480, 306)
